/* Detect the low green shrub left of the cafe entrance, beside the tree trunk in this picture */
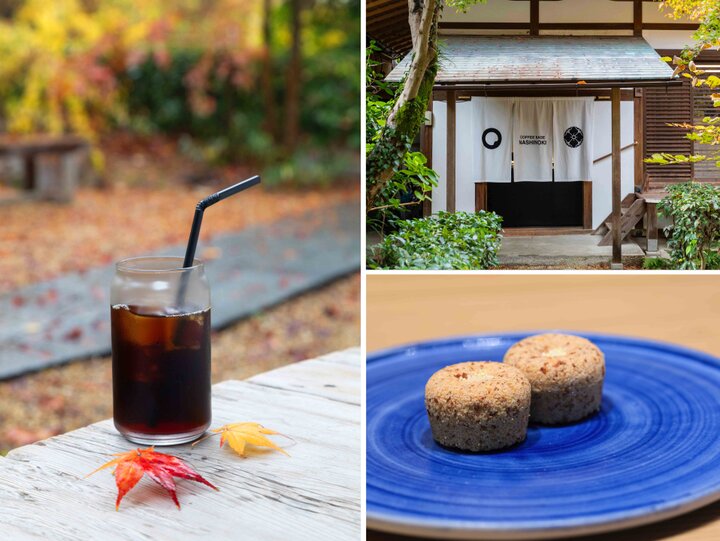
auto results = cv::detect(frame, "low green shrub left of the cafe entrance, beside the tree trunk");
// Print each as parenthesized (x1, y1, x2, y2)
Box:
(369, 211, 502, 270)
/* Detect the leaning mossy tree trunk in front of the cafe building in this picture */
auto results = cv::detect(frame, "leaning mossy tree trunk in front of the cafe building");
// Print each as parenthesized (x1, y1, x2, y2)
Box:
(367, 0, 442, 208)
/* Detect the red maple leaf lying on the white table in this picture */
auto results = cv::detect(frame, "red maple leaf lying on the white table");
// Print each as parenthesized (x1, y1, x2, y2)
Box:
(87, 447, 218, 511)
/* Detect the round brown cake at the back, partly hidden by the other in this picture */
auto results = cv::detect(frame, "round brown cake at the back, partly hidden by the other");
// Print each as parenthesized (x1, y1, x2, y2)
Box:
(505, 334, 605, 425)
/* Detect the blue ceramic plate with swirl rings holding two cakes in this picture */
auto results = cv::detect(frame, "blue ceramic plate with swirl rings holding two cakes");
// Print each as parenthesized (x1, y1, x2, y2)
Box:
(367, 333, 720, 539)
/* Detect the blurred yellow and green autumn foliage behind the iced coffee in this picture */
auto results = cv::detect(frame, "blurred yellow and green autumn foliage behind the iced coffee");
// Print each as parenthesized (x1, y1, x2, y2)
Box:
(0, 0, 360, 182)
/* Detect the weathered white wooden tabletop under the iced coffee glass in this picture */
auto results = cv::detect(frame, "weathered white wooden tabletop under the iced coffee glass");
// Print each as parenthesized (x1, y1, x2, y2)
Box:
(0, 349, 362, 540)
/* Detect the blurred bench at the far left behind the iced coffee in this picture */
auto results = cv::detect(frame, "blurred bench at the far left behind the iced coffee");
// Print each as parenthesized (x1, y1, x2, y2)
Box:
(0, 134, 89, 202)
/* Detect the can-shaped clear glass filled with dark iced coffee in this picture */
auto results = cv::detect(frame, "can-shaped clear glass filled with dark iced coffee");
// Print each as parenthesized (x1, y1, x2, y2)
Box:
(110, 257, 211, 445)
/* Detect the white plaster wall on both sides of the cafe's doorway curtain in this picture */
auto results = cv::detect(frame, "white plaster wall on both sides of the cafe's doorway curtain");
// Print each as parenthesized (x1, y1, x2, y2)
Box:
(432, 101, 635, 228)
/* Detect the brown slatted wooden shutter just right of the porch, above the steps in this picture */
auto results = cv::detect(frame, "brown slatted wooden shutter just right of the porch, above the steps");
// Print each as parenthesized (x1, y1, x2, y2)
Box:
(643, 81, 693, 190)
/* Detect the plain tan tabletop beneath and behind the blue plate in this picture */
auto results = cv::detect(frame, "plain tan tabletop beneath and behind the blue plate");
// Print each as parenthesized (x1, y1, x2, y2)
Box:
(367, 273, 720, 541)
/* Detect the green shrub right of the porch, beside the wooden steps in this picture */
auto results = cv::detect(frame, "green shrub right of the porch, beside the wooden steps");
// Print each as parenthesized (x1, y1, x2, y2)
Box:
(658, 182, 720, 270)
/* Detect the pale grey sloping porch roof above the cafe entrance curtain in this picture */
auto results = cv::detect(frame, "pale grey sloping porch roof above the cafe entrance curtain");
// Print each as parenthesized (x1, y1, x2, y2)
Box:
(386, 35, 673, 85)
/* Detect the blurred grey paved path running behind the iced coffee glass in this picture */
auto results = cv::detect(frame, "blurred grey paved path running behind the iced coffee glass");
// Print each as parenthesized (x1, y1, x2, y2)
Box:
(0, 196, 360, 379)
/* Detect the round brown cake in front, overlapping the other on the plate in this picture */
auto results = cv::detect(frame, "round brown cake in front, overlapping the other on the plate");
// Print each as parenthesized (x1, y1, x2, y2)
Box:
(425, 362, 530, 451)
